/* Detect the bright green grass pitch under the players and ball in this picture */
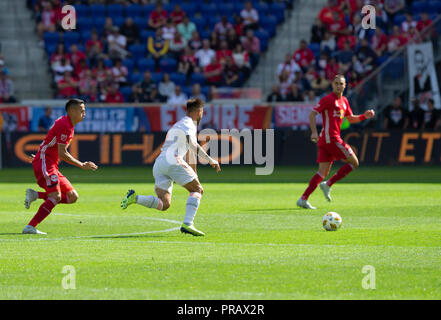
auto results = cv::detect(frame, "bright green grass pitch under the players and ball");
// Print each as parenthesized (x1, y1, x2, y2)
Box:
(0, 165, 441, 300)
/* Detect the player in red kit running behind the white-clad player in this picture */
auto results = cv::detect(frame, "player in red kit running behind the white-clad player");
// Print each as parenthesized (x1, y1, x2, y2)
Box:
(23, 99, 98, 234)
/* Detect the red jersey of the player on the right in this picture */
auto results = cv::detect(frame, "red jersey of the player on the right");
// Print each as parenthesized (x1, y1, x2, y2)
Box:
(314, 92, 352, 146)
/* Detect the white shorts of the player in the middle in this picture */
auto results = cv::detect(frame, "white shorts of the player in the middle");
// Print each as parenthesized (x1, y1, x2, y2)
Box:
(153, 157, 198, 193)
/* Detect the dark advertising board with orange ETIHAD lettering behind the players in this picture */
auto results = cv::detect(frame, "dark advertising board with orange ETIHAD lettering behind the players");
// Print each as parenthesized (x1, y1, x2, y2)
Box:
(2, 131, 441, 167)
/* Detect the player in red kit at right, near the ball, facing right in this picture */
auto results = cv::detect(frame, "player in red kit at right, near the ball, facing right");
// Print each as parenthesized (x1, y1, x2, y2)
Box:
(297, 74, 375, 209)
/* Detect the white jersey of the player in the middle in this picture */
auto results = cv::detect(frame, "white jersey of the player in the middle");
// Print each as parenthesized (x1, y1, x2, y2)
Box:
(158, 116, 197, 160)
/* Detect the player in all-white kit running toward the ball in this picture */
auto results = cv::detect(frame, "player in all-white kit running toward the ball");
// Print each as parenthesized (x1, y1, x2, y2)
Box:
(121, 98, 220, 236)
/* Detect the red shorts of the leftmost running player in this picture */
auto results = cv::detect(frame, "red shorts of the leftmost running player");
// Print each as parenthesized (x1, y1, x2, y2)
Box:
(32, 160, 74, 193)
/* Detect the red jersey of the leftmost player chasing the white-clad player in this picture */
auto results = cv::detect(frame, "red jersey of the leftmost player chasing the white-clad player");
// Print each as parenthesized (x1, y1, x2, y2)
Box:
(35, 116, 74, 167)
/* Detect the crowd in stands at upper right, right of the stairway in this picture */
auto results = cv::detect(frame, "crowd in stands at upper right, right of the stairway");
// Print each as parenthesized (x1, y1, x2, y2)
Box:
(267, 0, 441, 103)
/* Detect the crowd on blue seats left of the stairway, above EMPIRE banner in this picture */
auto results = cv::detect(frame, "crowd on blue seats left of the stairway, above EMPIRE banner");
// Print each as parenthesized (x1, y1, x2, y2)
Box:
(29, 0, 293, 103)
